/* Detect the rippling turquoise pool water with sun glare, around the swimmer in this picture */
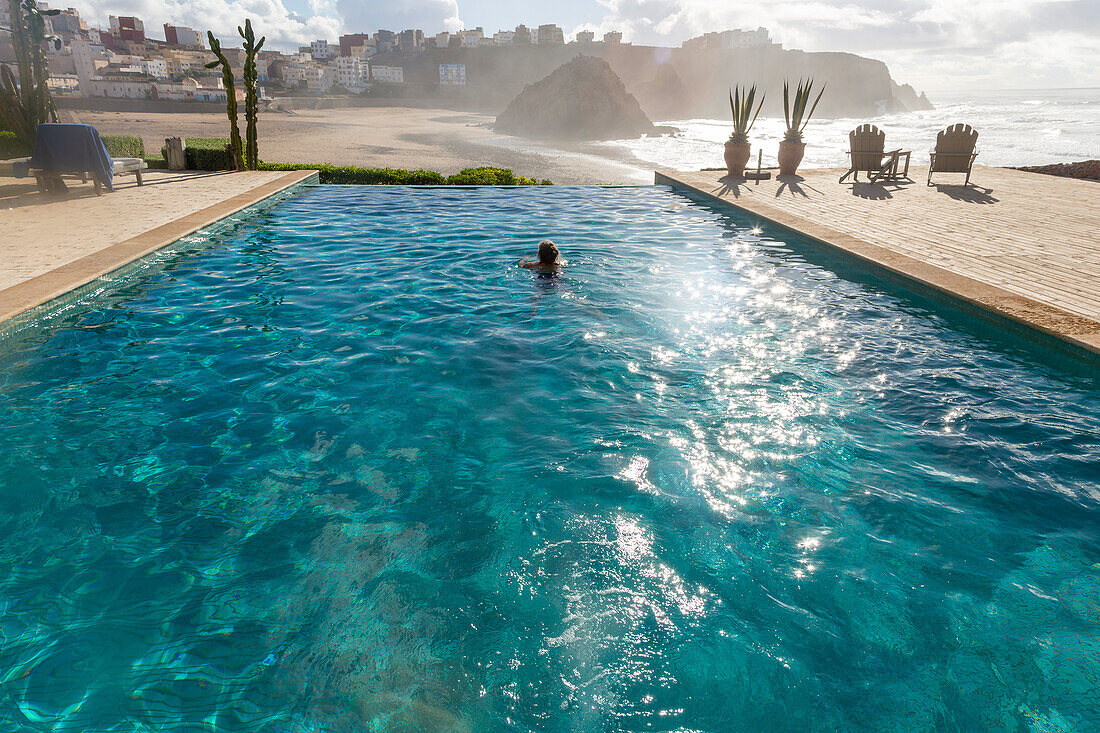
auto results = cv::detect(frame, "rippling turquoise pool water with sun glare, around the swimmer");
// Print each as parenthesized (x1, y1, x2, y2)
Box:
(0, 186, 1100, 732)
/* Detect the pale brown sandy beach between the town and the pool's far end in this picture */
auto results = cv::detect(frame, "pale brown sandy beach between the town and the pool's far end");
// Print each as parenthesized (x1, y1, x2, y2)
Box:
(65, 107, 653, 184)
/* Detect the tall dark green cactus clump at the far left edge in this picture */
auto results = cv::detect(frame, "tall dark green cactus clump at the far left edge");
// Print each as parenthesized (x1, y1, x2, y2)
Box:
(0, 0, 61, 149)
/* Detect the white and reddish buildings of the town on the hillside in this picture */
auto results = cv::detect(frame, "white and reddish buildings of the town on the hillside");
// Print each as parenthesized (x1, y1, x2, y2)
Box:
(0, 2, 773, 101)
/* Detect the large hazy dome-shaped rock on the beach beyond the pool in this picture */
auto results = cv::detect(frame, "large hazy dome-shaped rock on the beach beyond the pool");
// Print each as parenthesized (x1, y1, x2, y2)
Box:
(494, 55, 656, 140)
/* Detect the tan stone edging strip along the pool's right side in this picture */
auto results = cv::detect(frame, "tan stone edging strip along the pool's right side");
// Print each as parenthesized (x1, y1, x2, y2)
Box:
(653, 171, 1100, 354)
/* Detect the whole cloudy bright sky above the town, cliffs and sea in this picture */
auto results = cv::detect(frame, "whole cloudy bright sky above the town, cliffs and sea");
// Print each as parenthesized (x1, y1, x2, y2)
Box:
(70, 0, 1100, 91)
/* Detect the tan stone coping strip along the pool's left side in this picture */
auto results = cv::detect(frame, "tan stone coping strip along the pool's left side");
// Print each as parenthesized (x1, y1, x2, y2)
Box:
(0, 171, 317, 324)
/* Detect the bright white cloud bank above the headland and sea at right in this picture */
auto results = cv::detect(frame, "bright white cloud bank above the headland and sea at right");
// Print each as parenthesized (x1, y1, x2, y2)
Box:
(574, 0, 1100, 89)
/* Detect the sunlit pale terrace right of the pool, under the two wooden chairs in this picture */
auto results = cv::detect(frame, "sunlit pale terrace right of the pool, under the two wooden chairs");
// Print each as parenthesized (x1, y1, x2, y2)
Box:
(656, 166, 1100, 353)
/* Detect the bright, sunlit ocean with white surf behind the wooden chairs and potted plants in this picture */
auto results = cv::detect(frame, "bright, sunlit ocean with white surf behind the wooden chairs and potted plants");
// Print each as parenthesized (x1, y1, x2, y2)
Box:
(592, 88, 1100, 171)
